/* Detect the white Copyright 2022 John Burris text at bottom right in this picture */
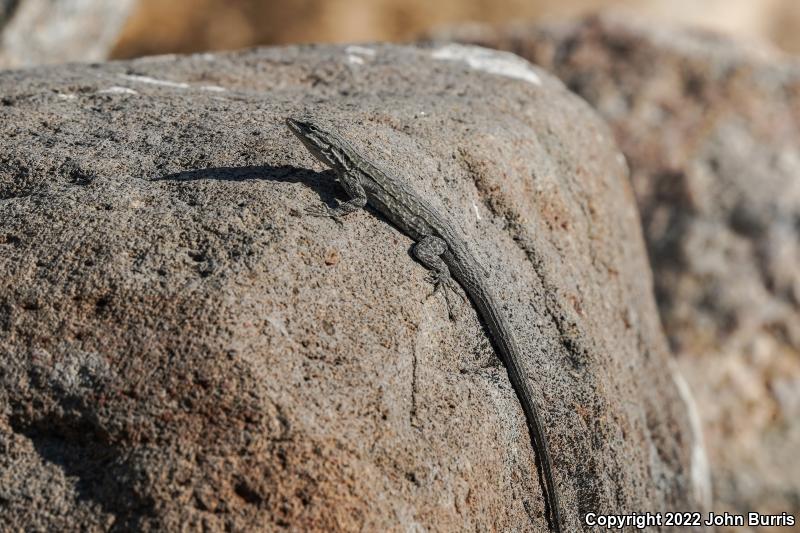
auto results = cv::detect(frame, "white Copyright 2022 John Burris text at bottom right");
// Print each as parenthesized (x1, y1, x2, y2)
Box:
(583, 512, 797, 531)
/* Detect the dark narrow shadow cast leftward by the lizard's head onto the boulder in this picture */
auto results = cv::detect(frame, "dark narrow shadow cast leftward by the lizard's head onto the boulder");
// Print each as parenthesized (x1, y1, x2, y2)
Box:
(151, 165, 347, 207)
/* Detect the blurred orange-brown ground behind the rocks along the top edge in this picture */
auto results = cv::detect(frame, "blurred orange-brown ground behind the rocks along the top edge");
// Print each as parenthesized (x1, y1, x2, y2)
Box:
(108, 0, 800, 57)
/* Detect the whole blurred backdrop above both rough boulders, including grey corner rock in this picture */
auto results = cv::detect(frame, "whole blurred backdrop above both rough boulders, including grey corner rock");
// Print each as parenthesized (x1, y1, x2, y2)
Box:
(0, 0, 800, 68)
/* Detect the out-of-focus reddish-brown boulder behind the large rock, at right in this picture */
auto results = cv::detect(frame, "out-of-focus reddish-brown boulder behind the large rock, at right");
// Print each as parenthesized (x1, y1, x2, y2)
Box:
(438, 17, 800, 528)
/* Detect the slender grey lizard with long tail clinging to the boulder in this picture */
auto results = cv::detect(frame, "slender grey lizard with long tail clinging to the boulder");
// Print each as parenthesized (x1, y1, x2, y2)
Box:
(286, 118, 562, 533)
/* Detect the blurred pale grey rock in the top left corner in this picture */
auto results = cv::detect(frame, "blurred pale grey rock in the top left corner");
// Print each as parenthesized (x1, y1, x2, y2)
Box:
(0, 0, 136, 68)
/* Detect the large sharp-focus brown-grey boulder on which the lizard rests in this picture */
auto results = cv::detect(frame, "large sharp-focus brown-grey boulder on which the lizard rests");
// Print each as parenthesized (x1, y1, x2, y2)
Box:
(0, 46, 702, 531)
